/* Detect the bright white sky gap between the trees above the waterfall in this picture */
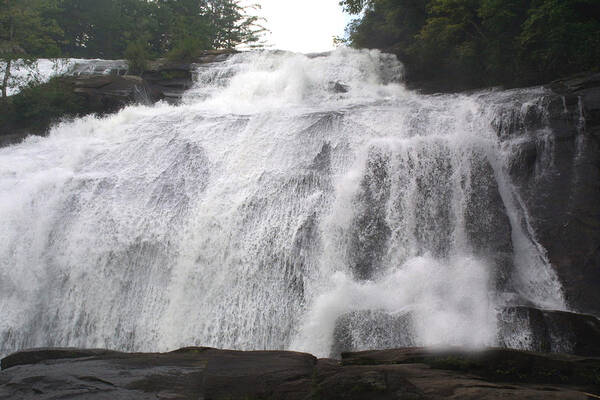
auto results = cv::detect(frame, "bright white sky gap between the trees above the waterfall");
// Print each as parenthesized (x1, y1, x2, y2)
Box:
(254, 0, 350, 53)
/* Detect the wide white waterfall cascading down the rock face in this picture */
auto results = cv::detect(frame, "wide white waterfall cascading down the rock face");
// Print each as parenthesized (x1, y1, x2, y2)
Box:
(0, 49, 565, 355)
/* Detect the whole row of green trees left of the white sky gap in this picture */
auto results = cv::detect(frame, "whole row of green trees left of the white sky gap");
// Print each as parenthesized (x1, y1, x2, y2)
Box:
(0, 0, 264, 98)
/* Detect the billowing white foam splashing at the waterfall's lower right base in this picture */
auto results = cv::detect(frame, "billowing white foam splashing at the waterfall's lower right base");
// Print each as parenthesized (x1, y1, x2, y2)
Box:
(291, 256, 496, 357)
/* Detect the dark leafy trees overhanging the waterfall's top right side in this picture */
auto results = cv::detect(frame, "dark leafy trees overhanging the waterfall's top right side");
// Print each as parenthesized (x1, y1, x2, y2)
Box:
(340, 0, 600, 88)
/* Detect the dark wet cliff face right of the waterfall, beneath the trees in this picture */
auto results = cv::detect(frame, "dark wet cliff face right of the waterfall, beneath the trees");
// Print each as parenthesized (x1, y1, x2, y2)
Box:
(499, 74, 600, 316)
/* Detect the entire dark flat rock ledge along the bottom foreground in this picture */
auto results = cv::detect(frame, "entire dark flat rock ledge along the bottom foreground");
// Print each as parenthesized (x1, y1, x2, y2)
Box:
(0, 348, 600, 400)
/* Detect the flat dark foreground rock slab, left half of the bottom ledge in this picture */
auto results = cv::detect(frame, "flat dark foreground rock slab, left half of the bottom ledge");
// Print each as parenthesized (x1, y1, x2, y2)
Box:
(0, 348, 316, 399)
